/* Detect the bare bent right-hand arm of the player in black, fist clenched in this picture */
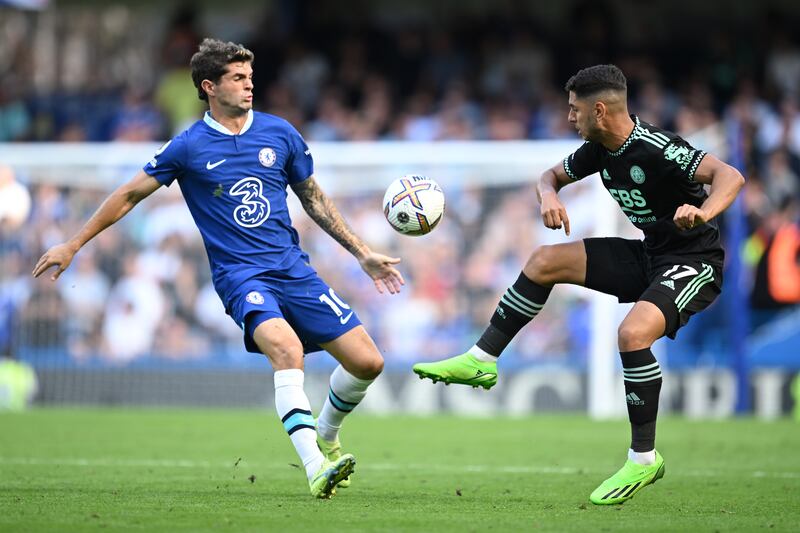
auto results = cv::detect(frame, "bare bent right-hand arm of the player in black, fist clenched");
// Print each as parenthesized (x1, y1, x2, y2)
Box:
(673, 154, 744, 230)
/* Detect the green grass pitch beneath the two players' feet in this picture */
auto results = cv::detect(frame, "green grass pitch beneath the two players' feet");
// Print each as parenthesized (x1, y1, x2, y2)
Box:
(0, 409, 800, 533)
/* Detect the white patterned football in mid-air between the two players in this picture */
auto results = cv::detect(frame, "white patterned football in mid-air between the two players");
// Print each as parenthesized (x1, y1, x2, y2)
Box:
(383, 174, 445, 235)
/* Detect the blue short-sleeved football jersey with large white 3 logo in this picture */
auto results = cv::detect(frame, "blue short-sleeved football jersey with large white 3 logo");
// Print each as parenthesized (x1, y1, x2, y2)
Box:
(144, 111, 314, 301)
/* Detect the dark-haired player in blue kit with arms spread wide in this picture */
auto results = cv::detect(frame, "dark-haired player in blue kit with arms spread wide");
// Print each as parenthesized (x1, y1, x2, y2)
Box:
(33, 39, 404, 498)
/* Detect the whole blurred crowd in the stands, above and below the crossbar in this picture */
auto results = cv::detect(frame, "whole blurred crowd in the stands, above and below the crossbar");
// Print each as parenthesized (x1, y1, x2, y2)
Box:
(0, 2, 800, 361)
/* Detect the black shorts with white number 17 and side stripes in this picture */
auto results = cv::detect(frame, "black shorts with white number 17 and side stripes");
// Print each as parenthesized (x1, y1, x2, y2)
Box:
(583, 237, 722, 339)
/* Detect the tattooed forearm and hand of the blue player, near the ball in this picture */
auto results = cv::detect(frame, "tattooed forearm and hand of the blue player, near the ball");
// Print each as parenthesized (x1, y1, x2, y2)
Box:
(292, 176, 405, 294)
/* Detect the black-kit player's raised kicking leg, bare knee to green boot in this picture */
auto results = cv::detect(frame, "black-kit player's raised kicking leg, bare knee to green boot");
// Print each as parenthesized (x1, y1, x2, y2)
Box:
(414, 241, 586, 389)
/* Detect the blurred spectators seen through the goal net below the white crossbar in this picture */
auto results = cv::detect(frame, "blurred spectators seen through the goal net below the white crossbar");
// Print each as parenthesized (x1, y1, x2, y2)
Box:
(0, 175, 588, 365)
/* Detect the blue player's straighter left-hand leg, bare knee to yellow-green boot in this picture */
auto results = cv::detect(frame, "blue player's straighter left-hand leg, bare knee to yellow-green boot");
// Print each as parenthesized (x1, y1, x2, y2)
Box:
(253, 314, 355, 498)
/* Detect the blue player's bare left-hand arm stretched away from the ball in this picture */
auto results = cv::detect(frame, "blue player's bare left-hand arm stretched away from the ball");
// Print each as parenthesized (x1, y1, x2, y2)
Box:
(33, 170, 161, 281)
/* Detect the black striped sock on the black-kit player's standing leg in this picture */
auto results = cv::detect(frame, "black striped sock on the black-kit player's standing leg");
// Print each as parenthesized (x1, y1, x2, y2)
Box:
(619, 348, 661, 452)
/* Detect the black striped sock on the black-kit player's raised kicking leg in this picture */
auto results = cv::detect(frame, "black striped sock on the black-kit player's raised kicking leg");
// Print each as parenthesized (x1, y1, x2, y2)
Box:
(476, 273, 552, 356)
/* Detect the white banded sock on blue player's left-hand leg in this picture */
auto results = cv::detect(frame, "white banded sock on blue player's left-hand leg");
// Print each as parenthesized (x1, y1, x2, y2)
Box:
(274, 368, 323, 479)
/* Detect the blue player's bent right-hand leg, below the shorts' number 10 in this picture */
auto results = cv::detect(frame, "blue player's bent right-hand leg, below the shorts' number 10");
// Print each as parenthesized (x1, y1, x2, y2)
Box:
(317, 326, 383, 488)
